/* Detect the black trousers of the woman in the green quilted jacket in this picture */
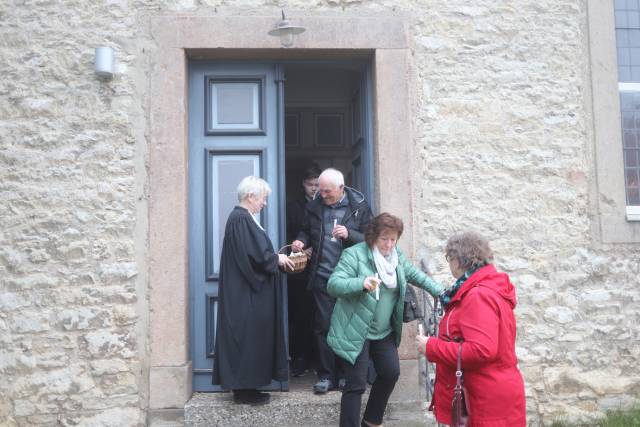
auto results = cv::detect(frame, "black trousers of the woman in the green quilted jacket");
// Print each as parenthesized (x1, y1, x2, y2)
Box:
(340, 333, 400, 427)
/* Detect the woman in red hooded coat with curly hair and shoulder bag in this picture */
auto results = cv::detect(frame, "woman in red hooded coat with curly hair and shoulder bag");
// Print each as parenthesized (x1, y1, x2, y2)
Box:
(416, 232, 526, 427)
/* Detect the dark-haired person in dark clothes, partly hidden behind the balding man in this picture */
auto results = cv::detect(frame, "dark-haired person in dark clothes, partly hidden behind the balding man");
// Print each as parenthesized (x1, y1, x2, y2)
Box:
(287, 164, 320, 377)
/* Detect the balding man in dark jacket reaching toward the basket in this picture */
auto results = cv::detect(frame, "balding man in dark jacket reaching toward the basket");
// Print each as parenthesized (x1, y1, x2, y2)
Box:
(292, 168, 372, 394)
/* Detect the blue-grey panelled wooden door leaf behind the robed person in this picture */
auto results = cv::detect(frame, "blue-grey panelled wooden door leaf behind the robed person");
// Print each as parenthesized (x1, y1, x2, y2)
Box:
(188, 61, 286, 391)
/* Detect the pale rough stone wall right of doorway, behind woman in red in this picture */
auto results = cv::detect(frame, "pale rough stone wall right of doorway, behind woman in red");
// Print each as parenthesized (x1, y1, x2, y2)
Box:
(414, 1, 640, 422)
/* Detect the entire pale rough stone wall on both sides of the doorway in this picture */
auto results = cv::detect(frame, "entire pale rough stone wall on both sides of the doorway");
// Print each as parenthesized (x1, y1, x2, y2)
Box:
(0, 0, 640, 425)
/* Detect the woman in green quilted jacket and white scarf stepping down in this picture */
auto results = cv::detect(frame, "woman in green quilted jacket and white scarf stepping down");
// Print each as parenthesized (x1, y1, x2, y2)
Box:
(327, 213, 443, 427)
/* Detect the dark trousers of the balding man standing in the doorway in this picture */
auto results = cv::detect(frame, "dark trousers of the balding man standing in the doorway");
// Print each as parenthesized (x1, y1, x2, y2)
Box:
(312, 278, 342, 384)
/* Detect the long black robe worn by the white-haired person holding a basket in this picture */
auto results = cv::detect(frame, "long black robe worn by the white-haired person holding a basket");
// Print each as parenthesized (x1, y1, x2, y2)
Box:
(213, 206, 288, 390)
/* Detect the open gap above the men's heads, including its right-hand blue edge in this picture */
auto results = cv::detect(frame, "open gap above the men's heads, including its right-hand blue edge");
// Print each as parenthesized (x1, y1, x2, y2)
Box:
(284, 62, 371, 202)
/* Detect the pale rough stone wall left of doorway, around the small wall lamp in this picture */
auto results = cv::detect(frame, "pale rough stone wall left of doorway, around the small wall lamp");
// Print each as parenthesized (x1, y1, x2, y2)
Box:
(0, 1, 147, 426)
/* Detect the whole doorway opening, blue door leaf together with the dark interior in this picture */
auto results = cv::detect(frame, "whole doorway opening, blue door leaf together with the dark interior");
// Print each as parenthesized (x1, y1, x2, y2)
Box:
(189, 60, 374, 391)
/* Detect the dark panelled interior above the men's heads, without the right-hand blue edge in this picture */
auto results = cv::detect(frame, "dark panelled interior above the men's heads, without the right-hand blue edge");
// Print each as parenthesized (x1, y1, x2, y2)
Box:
(285, 63, 362, 204)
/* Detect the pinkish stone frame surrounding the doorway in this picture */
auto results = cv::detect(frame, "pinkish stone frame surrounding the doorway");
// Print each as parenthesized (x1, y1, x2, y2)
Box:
(148, 14, 412, 416)
